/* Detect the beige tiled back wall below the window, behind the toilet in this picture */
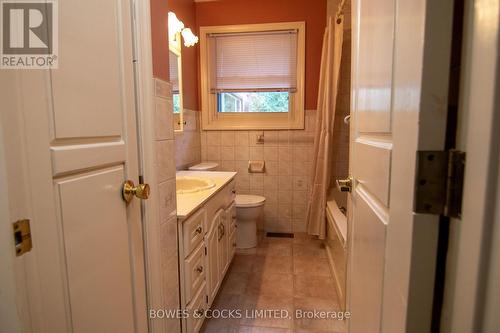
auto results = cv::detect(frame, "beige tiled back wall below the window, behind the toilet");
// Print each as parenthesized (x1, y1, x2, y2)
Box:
(201, 110, 316, 232)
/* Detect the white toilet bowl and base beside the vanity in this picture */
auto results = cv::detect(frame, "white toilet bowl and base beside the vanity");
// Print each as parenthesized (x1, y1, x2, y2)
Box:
(235, 194, 266, 249)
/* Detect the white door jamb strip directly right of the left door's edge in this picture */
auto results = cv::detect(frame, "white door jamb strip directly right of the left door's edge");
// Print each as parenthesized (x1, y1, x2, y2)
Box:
(131, 0, 173, 333)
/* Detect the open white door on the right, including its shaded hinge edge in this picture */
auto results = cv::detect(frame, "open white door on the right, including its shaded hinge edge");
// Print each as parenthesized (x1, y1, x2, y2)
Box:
(347, 0, 453, 333)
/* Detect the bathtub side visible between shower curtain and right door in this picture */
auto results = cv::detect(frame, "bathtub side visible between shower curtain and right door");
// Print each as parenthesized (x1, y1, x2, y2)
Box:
(325, 191, 347, 309)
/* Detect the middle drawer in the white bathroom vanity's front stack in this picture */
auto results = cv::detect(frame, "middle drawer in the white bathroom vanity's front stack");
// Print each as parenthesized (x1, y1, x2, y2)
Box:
(184, 243, 205, 303)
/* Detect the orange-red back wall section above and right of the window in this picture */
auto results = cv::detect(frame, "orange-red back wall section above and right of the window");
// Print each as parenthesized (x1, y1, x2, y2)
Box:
(196, 0, 326, 109)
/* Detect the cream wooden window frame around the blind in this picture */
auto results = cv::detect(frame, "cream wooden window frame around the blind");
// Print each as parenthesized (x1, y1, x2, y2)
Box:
(200, 22, 306, 130)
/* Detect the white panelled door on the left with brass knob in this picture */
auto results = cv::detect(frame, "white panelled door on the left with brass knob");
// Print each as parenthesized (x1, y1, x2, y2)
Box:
(2, 0, 147, 333)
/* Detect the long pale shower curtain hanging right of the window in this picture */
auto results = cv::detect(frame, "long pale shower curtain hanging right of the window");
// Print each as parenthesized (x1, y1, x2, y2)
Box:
(307, 16, 344, 239)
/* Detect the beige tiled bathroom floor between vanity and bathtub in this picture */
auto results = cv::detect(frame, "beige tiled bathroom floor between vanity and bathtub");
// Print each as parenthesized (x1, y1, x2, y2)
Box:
(201, 235, 345, 333)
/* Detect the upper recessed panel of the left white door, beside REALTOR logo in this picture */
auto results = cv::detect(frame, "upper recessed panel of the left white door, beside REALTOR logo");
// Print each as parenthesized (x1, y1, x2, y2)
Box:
(51, 0, 128, 139)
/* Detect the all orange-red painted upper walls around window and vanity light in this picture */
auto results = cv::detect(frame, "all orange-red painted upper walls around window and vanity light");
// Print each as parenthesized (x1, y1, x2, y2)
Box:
(151, 0, 326, 110)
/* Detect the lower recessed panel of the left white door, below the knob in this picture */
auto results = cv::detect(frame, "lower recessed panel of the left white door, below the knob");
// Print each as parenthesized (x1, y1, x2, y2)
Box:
(55, 166, 134, 332)
